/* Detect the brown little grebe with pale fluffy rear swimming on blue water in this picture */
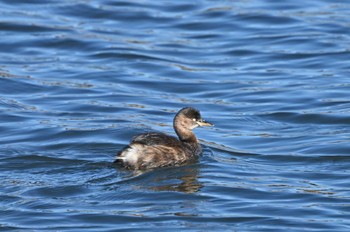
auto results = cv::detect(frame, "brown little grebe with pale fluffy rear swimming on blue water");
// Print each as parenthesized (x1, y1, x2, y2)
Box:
(114, 107, 213, 170)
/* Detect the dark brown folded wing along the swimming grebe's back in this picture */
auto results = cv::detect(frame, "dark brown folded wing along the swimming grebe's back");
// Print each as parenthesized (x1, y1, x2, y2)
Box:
(131, 132, 180, 147)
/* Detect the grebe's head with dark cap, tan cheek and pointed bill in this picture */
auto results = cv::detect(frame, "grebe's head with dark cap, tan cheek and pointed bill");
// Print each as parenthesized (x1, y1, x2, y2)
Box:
(174, 107, 214, 130)
